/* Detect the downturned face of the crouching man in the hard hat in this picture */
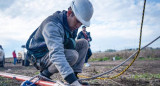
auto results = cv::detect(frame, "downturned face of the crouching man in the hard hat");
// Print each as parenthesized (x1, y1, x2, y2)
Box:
(67, 13, 82, 30)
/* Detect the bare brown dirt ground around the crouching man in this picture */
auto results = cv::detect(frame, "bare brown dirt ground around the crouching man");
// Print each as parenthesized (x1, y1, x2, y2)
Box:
(0, 60, 160, 86)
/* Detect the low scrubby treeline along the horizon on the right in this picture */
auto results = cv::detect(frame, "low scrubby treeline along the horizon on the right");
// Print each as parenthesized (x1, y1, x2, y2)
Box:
(92, 47, 160, 59)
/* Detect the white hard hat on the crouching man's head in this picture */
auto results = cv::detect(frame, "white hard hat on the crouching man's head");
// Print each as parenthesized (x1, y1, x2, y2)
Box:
(71, 0, 93, 27)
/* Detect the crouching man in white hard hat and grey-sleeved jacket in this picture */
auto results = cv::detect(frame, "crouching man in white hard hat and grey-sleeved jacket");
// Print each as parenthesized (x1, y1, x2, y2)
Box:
(26, 0, 93, 86)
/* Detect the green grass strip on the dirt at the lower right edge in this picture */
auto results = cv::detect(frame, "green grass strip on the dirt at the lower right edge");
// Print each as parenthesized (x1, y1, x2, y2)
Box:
(132, 73, 160, 79)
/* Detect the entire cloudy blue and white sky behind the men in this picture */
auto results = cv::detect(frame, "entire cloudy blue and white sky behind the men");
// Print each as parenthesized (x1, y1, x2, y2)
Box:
(0, 0, 160, 56)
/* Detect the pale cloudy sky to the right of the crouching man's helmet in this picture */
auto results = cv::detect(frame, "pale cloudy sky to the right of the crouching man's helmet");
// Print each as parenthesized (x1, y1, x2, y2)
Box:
(88, 0, 160, 51)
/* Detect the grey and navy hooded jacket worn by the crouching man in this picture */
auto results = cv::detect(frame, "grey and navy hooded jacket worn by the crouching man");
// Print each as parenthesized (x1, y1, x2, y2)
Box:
(26, 11, 78, 81)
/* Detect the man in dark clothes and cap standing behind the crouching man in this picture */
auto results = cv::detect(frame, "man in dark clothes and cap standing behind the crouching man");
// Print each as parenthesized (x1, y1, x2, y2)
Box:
(77, 26, 92, 67)
